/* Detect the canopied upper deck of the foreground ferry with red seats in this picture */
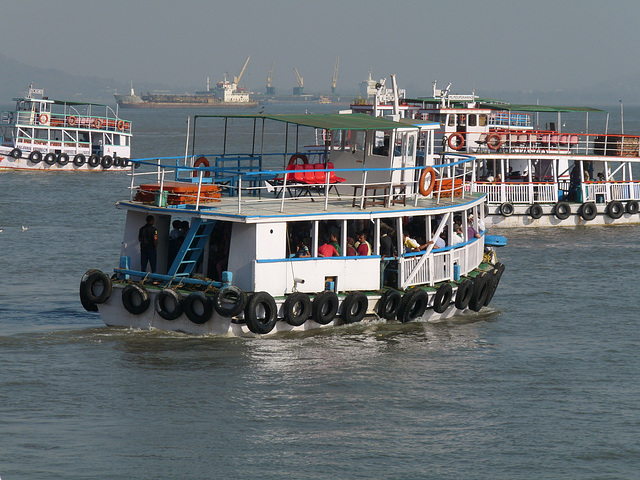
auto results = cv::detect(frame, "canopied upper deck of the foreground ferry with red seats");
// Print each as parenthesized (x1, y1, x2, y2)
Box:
(120, 115, 483, 223)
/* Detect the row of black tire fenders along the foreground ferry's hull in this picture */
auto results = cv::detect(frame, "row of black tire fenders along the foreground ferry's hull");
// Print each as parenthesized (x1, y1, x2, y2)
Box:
(80, 263, 505, 334)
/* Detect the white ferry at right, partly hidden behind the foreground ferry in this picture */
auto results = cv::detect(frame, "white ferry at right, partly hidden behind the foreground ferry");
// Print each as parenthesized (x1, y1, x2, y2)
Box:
(351, 76, 640, 227)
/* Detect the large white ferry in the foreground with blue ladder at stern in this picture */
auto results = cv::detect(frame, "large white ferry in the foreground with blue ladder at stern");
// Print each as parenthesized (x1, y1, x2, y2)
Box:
(80, 115, 506, 336)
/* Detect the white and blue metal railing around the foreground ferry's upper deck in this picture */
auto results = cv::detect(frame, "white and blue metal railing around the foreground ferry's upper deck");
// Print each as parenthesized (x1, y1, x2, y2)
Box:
(129, 154, 475, 213)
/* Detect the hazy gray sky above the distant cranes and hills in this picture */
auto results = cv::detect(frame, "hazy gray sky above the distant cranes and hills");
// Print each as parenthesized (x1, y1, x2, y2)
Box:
(0, 0, 640, 94)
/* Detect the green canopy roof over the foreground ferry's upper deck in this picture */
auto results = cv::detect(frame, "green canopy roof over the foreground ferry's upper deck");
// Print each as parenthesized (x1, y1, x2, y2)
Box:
(194, 114, 418, 130)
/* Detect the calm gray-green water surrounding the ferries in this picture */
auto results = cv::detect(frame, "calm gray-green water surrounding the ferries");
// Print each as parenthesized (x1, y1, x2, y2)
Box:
(0, 107, 640, 480)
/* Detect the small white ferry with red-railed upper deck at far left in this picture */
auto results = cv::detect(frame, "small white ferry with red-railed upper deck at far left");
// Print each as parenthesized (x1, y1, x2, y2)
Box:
(0, 84, 131, 171)
